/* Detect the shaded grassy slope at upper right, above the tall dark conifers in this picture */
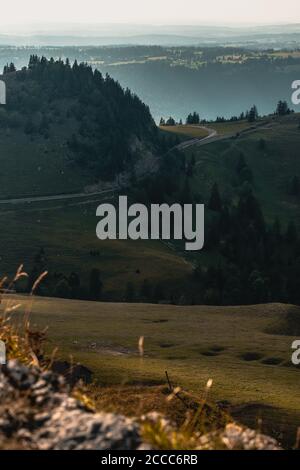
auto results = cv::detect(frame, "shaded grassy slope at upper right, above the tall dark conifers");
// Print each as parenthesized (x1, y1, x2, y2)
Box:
(186, 115, 300, 223)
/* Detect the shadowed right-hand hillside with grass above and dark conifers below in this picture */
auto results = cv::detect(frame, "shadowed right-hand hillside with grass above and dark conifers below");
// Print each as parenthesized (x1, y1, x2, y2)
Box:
(135, 113, 300, 305)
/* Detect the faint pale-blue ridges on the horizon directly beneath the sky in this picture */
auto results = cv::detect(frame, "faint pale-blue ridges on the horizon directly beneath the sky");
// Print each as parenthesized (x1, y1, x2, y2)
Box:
(0, 24, 300, 47)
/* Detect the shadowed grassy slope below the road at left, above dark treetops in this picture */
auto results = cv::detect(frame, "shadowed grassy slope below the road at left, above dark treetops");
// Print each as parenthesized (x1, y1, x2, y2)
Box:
(0, 198, 192, 296)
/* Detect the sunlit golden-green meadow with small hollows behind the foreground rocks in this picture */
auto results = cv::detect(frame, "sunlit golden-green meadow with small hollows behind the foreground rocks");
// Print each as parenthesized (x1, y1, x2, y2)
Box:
(3, 297, 300, 436)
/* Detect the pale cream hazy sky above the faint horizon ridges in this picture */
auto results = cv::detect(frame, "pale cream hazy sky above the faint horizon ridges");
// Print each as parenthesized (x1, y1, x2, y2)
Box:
(0, 0, 300, 29)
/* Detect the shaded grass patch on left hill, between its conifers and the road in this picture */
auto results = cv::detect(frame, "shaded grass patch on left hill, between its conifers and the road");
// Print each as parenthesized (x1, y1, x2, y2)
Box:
(0, 119, 91, 198)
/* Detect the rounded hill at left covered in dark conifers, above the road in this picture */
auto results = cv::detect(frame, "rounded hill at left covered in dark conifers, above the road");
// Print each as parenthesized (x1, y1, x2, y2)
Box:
(0, 55, 164, 196)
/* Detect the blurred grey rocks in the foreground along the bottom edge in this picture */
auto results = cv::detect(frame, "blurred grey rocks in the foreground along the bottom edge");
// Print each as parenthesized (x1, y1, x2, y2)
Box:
(0, 361, 280, 450)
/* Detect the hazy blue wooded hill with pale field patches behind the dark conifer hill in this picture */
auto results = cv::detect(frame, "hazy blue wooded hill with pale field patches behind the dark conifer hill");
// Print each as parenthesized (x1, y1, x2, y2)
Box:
(0, 45, 300, 123)
